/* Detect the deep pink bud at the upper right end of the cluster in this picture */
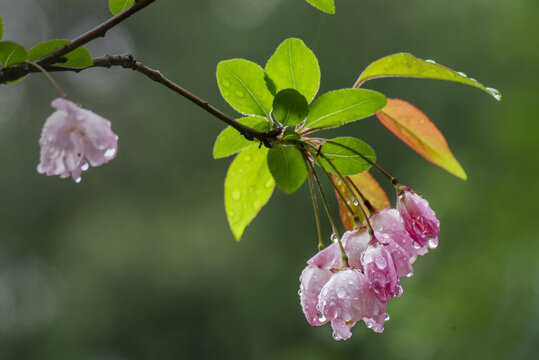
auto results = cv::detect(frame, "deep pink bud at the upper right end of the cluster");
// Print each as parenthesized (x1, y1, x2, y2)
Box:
(397, 188, 440, 250)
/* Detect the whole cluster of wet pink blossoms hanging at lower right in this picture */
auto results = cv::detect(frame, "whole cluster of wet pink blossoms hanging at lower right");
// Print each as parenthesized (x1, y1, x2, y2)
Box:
(300, 187, 440, 340)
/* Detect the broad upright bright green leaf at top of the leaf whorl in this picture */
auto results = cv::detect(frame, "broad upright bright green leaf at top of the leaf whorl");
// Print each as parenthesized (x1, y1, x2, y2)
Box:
(266, 39, 320, 102)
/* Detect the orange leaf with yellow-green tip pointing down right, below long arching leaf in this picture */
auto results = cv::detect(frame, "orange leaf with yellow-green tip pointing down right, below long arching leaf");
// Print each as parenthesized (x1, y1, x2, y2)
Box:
(376, 99, 467, 180)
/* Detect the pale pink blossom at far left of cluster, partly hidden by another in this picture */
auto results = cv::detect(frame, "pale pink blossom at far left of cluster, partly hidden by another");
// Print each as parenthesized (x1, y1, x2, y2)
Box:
(299, 265, 332, 326)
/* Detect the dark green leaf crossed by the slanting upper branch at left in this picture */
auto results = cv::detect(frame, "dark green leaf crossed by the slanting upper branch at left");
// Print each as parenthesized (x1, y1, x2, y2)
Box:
(27, 39, 94, 69)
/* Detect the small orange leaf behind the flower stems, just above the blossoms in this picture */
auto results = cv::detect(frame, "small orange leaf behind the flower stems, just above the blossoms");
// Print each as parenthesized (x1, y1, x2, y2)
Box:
(333, 171, 391, 230)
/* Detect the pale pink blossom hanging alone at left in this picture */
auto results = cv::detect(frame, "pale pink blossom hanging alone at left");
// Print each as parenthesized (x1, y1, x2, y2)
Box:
(37, 98, 118, 182)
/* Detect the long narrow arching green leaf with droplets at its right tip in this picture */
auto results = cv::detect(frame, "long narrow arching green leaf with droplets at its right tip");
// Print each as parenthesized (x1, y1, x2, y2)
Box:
(354, 53, 502, 101)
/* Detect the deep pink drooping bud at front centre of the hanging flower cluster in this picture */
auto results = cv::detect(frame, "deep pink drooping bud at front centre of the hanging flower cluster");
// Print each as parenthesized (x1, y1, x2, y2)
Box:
(362, 244, 402, 302)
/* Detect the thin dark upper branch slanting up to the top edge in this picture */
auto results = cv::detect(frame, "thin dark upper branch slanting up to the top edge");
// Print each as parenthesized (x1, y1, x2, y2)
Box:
(36, 0, 156, 66)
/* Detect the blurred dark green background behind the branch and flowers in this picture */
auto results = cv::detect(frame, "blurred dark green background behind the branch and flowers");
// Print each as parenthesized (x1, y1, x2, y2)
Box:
(0, 0, 539, 360)
